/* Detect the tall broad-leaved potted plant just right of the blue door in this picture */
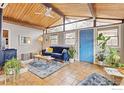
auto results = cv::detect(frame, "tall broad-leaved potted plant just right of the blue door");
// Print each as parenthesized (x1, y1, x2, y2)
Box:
(96, 33, 110, 65)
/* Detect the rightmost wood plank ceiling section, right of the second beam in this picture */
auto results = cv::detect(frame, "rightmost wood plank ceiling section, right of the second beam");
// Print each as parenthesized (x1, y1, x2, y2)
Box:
(94, 3, 124, 19)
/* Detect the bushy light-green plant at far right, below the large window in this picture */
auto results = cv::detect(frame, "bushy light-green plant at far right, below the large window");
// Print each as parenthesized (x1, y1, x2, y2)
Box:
(105, 48, 122, 68)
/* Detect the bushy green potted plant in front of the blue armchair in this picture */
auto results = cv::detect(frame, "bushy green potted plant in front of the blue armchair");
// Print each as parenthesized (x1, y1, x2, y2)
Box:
(4, 58, 21, 75)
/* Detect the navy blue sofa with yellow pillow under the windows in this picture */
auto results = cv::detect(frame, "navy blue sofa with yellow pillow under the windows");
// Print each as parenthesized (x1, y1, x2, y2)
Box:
(42, 46, 69, 61)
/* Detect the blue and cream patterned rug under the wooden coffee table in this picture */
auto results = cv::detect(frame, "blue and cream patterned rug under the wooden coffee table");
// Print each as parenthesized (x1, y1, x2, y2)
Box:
(28, 61, 67, 79)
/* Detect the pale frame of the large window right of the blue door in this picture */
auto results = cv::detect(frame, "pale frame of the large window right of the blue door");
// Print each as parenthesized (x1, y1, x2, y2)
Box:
(97, 26, 120, 48)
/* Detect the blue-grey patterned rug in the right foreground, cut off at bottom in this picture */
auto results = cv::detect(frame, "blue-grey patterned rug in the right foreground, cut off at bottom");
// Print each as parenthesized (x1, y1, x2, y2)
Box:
(78, 73, 116, 86)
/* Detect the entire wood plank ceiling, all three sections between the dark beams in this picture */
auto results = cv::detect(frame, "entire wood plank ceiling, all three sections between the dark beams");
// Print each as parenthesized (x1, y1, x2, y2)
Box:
(3, 3, 124, 29)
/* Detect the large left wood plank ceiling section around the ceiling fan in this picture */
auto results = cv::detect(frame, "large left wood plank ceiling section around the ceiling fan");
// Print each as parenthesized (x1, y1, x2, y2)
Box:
(3, 3, 60, 28)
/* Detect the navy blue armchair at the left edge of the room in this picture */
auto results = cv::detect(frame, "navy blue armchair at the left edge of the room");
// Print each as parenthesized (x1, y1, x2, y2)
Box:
(0, 49, 17, 67)
